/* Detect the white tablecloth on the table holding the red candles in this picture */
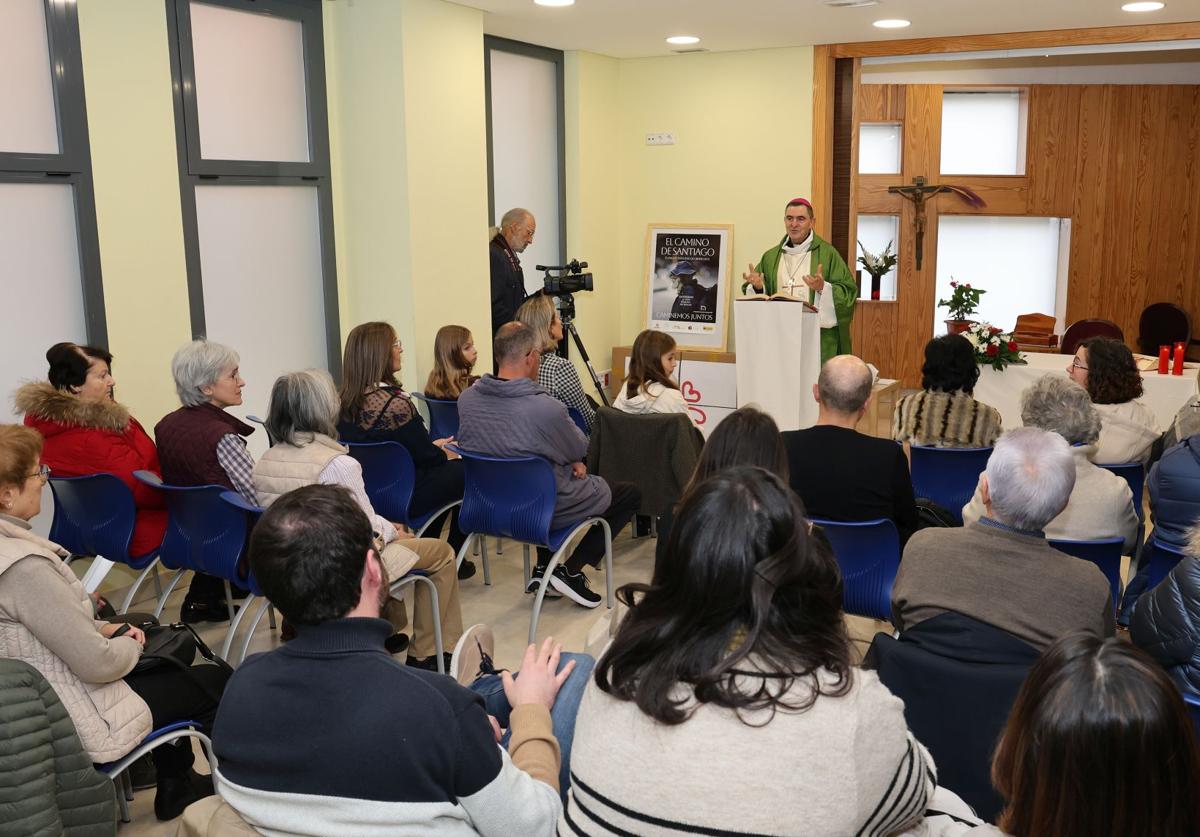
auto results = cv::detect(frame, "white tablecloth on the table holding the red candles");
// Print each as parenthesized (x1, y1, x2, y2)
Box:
(974, 353, 1198, 430)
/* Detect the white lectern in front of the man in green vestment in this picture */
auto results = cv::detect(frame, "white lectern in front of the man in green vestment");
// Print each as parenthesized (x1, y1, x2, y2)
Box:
(733, 300, 821, 430)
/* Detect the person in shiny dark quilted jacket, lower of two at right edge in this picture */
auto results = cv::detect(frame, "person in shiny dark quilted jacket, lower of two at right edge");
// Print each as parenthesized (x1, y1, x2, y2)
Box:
(1129, 525, 1200, 700)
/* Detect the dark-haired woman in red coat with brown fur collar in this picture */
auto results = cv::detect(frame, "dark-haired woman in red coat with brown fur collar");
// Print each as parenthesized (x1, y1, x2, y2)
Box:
(14, 343, 167, 556)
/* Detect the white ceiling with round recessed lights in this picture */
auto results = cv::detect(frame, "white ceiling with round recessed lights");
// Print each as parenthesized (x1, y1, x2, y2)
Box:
(457, 0, 1200, 58)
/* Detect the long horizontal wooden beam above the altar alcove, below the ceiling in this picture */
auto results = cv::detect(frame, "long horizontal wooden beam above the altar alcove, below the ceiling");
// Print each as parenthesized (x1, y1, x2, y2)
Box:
(827, 22, 1200, 58)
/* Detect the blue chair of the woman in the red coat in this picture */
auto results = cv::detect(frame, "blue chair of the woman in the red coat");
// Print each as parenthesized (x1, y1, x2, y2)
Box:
(49, 474, 167, 614)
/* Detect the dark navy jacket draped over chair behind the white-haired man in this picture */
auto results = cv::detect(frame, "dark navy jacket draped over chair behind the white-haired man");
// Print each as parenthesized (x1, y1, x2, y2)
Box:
(863, 612, 1038, 821)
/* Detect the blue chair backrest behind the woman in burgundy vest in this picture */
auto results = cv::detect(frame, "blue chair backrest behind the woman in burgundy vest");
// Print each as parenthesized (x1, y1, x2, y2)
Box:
(133, 471, 250, 585)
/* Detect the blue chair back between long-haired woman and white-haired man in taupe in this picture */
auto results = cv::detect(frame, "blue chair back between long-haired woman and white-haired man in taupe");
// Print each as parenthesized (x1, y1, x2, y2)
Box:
(812, 518, 900, 622)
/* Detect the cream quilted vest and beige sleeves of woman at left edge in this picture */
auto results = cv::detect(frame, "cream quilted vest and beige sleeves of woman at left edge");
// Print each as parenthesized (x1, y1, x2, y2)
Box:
(0, 517, 151, 763)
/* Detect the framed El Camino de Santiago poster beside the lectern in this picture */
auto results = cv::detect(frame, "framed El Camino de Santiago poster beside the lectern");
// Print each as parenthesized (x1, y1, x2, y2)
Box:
(646, 224, 733, 351)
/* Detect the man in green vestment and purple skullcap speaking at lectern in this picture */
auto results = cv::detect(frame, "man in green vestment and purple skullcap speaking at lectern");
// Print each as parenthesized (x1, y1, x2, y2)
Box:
(742, 198, 858, 363)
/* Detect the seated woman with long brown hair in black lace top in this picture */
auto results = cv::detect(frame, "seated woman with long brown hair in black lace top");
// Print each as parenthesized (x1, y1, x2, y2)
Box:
(337, 323, 475, 578)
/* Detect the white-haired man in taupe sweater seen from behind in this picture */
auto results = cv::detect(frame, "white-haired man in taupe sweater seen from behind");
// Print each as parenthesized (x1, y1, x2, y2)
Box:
(892, 427, 1108, 650)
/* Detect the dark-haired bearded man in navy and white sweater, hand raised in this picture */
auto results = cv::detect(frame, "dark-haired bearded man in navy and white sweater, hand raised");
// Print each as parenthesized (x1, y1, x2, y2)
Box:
(209, 486, 586, 837)
